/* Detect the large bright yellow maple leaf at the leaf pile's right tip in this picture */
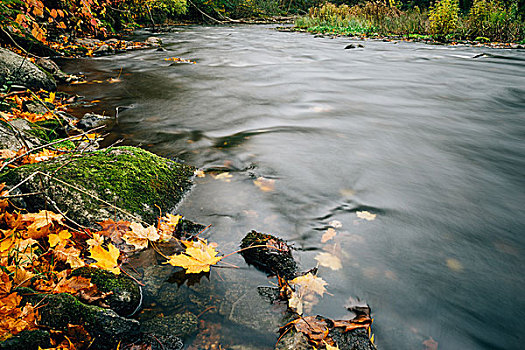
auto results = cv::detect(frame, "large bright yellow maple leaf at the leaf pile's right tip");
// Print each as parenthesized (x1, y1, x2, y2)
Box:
(166, 240, 222, 273)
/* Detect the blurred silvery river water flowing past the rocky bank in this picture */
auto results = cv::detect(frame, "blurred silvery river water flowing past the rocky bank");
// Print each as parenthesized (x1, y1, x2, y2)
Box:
(57, 26, 525, 350)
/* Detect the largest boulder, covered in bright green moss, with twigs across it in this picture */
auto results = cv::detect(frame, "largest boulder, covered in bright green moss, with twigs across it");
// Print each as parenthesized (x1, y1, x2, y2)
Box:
(0, 147, 195, 229)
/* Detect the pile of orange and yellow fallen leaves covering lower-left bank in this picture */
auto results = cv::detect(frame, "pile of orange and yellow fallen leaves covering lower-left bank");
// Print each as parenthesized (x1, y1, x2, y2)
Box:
(0, 179, 221, 349)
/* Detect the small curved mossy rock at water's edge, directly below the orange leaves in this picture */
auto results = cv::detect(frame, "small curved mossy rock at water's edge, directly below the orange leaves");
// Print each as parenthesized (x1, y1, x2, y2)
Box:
(71, 266, 142, 317)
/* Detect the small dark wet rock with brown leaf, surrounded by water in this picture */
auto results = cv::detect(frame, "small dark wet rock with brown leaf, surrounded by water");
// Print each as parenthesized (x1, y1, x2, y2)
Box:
(241, 230, 297, 279)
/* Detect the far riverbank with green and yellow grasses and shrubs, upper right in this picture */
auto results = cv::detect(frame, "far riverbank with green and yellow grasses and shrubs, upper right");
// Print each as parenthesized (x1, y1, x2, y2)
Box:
(290, 0, 525, 49)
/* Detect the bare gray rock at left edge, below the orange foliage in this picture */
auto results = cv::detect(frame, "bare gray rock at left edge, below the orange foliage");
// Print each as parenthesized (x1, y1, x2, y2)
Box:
(0, 48, 57, 91)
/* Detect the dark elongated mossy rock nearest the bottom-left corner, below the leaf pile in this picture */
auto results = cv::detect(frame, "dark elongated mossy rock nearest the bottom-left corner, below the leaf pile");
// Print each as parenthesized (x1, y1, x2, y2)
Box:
(17, 288, 140, 349)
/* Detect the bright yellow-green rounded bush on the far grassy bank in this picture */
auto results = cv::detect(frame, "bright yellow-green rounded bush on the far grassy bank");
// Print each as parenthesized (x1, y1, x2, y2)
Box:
(428, 0, 459, 35)
